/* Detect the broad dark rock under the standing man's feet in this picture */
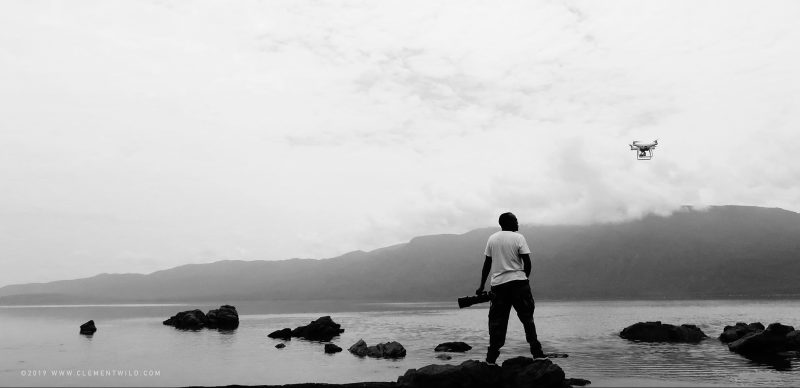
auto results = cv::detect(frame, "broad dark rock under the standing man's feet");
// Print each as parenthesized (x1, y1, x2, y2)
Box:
(397, 357, 588, 388)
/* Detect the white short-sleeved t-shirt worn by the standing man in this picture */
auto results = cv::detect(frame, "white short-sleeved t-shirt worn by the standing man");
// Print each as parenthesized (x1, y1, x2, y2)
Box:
(485, 230, 531, 286)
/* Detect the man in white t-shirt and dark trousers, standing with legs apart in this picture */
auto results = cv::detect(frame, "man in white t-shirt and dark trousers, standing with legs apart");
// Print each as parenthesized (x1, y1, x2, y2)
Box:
(475, 213, 544, 364)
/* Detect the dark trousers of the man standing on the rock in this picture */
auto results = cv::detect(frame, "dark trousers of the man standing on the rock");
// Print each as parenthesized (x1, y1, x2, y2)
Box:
(486, 280, 542, 362)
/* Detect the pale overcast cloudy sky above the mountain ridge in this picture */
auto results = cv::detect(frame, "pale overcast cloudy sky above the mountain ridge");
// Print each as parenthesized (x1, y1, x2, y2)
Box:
(0, 0, 800, 286)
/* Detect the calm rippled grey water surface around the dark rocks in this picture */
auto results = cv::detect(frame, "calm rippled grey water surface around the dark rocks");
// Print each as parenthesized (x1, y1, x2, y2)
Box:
(0, 301, 800, 386)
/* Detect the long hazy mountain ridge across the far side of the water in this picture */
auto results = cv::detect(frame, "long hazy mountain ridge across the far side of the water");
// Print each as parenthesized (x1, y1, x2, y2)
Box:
(0, 206, 800, 304)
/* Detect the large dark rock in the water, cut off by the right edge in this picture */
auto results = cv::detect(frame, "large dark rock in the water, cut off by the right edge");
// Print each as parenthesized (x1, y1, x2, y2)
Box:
(728, 323, 800, 355)
